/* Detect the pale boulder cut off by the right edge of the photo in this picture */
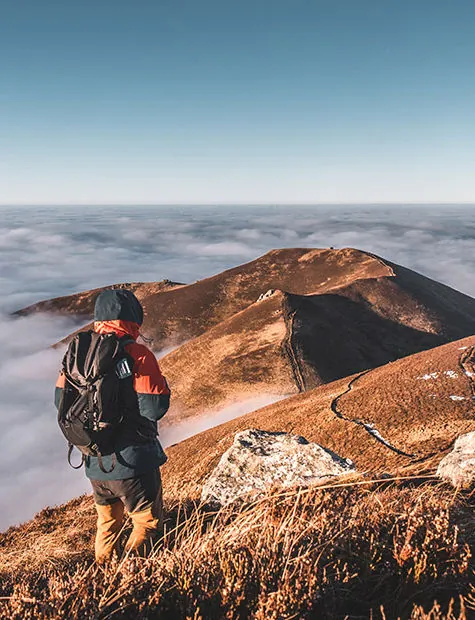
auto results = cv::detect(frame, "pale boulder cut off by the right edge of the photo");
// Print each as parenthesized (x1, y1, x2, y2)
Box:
(437, 431, 475, 489)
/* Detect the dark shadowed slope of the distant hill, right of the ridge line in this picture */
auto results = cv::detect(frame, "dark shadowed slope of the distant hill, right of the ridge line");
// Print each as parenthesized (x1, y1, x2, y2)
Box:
(285, 267, 475, 391)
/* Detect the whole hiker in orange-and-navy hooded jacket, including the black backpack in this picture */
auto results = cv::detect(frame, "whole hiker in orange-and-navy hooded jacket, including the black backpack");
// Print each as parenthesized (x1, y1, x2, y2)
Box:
(55, 289, 170, 563)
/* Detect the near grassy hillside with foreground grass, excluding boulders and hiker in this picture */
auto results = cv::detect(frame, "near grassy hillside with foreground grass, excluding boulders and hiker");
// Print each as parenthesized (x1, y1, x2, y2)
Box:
(0, 338, 475, 620)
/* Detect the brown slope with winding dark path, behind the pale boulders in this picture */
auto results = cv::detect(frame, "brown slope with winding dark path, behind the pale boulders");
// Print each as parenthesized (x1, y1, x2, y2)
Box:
(164, 337, 475, 496)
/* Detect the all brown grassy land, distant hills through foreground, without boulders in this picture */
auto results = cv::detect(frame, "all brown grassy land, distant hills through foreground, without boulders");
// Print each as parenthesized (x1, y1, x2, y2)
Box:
(6, 249, 475, 620)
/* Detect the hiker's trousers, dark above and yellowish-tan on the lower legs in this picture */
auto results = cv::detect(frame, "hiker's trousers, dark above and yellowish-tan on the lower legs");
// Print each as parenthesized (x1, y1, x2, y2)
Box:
(91, 469, 163, 564)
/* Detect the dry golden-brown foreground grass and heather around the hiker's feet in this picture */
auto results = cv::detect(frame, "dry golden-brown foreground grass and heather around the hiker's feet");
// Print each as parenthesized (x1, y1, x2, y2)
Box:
(0, 481, 475, 620)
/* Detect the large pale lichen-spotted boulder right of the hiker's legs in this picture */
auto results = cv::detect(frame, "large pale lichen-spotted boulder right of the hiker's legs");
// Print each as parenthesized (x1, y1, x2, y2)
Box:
(201, 429, 355, 506)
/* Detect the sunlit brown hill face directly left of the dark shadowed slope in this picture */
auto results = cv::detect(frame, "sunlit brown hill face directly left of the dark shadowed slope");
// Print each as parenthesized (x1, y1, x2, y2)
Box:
(160, 291, 299, 426)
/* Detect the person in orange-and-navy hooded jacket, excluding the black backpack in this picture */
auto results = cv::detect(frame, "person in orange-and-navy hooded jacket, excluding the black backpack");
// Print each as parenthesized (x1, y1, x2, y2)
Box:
(55, 289, 170, 563)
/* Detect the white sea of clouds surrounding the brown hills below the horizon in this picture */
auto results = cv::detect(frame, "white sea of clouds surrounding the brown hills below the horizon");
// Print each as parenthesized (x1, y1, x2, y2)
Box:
(0, 205, 475, 530)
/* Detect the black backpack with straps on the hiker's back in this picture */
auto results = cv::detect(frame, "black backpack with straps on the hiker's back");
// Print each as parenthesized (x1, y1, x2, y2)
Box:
(58, 331, 133, 473)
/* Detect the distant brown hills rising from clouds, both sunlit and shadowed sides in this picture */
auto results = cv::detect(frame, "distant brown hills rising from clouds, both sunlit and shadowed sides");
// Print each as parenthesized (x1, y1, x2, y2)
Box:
(17, 248, 475, 424)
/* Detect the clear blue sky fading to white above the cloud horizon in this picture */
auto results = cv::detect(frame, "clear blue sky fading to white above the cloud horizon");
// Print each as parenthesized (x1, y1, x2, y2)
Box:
(0, 0, 475, 204)
